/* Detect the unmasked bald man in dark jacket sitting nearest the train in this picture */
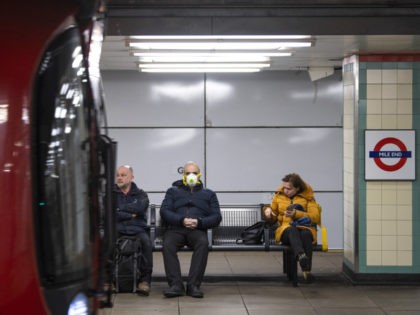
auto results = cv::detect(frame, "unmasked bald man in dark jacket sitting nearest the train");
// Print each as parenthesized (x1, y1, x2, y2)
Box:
(113, 165, 153, 296)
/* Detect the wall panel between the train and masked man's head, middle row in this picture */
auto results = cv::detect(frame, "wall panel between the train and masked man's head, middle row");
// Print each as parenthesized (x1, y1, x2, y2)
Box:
(110, 128, 204, 192)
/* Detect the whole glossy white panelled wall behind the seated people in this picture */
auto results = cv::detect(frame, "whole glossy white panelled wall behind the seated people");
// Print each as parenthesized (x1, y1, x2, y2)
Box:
(102, 71, 343, 249)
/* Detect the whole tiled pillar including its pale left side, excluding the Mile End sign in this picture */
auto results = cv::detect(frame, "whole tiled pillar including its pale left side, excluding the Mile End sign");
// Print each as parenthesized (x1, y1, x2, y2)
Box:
(343, 56, 420, 273)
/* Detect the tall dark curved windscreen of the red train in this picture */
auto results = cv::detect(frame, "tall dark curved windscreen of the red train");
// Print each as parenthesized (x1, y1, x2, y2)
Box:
(33, 28, 91, 286)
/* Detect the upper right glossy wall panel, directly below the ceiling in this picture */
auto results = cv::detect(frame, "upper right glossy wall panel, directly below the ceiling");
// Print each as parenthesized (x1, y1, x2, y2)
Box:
(206, 71, 343, 127)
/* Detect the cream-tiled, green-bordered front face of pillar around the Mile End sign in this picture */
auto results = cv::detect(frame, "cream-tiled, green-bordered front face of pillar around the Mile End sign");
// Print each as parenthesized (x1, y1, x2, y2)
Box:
(359, 58, 417, 273)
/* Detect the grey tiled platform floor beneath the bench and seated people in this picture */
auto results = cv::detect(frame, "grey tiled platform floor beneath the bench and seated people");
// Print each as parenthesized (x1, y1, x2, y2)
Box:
(101, 252, 420, 315)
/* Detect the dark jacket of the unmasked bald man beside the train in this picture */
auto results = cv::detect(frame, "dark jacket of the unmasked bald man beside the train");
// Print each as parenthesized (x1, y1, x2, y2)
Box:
(113, 182, 149, 235)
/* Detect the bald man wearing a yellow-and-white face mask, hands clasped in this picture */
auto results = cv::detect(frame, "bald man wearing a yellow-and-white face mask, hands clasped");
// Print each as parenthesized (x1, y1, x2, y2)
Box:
(160, 162, 222, 298)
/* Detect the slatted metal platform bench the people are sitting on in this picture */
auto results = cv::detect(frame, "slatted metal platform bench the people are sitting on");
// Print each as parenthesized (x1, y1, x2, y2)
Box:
(149, 204, 328, 286)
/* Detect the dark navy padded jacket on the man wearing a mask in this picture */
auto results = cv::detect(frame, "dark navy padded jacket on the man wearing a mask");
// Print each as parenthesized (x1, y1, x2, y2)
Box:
(160, 180, 222, 230)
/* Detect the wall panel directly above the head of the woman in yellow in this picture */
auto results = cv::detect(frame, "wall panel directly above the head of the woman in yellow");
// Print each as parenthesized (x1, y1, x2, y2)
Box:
(206, 128, 343, 192)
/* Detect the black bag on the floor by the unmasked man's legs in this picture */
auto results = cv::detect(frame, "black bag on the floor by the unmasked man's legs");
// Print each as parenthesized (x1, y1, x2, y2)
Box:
(114, 236, 141, 293)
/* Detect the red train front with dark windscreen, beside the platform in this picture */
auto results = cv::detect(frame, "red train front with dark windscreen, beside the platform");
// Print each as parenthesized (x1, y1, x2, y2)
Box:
(0, 0, 115, 315)
